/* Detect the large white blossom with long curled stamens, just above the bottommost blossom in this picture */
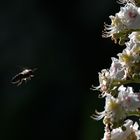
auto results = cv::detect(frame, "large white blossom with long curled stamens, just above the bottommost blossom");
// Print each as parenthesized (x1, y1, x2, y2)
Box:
(93, 85, 140, 128)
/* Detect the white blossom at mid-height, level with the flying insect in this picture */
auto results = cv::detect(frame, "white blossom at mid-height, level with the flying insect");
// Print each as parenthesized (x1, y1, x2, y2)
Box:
(95, 57, 126, 95)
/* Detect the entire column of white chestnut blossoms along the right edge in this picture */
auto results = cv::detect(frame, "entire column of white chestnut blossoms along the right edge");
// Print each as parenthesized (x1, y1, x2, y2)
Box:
(92, 0, 140, 140)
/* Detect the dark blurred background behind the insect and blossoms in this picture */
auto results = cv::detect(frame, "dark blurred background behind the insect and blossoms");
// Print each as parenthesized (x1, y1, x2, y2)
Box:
(0, 0, 121, 140)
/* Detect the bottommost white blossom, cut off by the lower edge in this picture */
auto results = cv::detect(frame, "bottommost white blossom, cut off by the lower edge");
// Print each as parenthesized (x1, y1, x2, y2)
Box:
(102, 120, 140, 140)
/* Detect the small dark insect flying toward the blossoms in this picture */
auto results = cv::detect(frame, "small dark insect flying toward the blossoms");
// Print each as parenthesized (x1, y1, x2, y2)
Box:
(11, 68, 37, 86)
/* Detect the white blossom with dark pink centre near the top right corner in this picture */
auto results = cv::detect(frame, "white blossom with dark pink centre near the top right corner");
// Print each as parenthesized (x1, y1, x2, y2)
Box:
(103, 3, 140, 37)
